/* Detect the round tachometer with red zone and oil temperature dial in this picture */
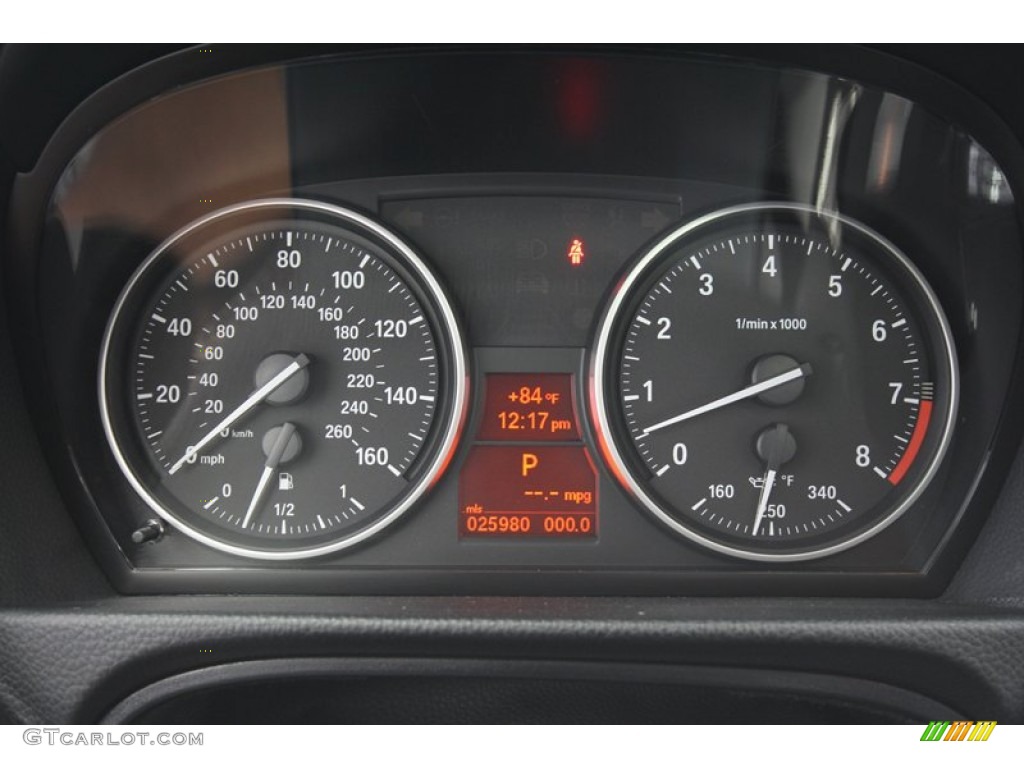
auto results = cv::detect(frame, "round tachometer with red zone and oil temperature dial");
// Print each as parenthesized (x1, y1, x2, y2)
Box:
(592, 206, 956, 560)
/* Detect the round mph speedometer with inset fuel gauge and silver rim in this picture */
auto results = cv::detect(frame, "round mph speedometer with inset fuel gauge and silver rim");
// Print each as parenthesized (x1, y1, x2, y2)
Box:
(100, 201, 466, 559)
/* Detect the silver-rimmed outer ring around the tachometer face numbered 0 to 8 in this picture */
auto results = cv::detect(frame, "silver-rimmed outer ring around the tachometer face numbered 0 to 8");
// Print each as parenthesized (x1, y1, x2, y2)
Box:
(589, 202, 959, 562)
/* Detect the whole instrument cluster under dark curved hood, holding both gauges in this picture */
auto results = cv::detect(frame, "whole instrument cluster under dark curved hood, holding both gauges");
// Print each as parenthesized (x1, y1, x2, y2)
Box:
(9, 49, 1022, 594)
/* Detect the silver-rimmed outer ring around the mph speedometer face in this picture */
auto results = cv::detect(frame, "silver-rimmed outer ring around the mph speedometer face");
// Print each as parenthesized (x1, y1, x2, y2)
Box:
(98, 198, 469, 560)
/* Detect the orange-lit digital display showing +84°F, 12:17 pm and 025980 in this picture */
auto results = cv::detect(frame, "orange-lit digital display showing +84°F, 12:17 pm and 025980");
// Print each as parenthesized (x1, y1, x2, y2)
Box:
(459, 374, 597, 538)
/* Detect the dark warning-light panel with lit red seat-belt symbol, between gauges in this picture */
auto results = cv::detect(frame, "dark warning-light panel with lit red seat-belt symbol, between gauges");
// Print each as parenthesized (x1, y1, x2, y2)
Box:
(381, 194, 680, 347)
